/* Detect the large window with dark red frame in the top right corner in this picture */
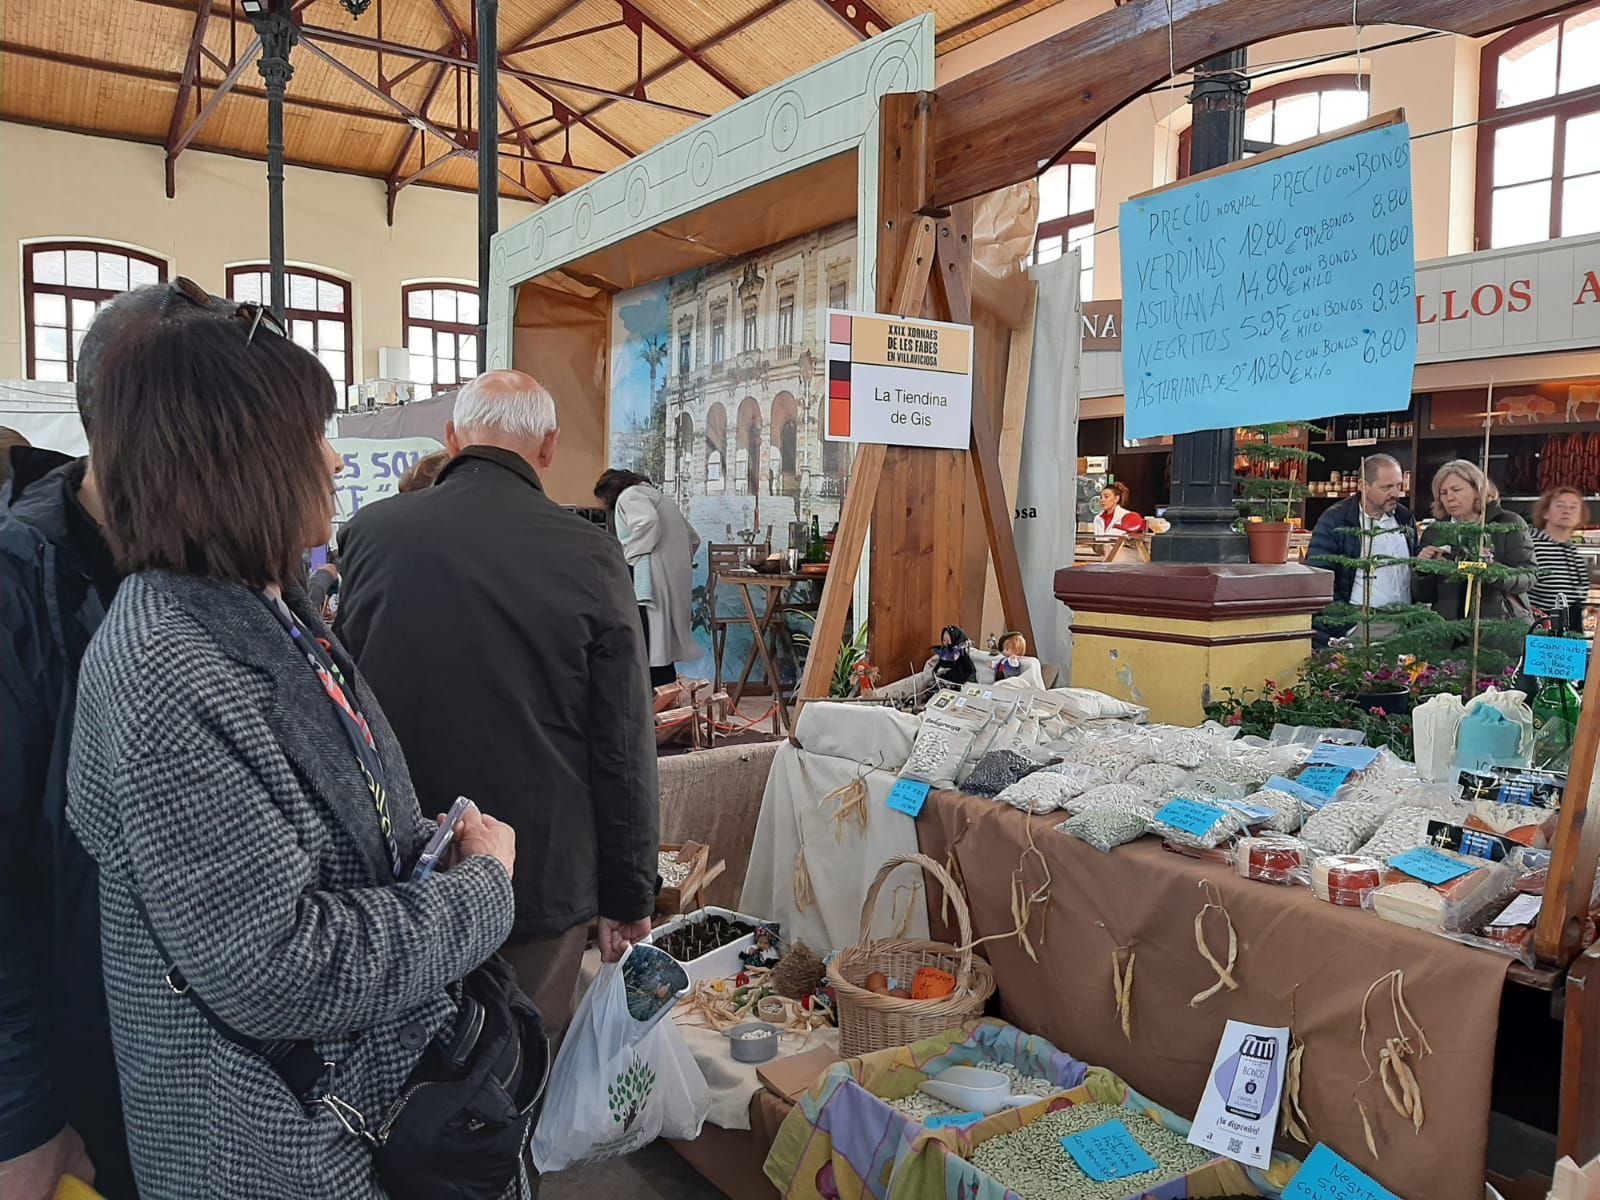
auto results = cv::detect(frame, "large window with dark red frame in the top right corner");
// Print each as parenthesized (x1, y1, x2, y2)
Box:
(1477, 5, 1600, 248)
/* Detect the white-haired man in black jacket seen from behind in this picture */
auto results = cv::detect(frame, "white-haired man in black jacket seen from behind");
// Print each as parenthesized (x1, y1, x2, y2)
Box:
(336, 371, 659, 1037)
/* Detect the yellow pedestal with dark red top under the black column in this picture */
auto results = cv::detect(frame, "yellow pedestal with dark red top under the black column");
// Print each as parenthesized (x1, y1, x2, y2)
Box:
(1056, 563, 1333, 725)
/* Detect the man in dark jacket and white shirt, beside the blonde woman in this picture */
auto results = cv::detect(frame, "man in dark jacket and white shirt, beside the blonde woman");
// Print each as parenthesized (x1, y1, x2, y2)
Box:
(1306, 454, 1416, 608)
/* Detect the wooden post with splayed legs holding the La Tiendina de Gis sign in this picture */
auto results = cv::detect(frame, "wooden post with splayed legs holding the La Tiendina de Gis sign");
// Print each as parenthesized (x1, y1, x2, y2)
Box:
(798, 91, 1037, 702)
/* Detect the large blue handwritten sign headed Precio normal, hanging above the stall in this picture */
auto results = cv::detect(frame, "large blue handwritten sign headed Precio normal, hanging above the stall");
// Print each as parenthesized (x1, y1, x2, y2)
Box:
(1120, 123, 1416, 438)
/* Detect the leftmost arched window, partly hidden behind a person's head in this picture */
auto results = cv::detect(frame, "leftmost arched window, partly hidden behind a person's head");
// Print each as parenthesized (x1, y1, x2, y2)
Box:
(22, 242, 166, 381)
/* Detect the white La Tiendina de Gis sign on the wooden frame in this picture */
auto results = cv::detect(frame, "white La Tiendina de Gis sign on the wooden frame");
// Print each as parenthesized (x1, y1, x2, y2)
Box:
(822, 309, 973, 450)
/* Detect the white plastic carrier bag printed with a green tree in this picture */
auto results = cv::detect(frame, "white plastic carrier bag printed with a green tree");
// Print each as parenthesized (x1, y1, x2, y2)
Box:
(533, 950, 710, 1174)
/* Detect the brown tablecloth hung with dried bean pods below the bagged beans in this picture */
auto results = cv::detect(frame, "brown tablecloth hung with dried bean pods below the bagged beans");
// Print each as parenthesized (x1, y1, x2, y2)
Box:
(917, 792, 1509, 1200)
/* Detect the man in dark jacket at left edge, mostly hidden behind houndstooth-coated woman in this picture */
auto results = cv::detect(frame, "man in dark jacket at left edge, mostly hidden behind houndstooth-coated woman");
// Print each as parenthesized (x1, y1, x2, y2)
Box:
(0, 288, 235, 1200)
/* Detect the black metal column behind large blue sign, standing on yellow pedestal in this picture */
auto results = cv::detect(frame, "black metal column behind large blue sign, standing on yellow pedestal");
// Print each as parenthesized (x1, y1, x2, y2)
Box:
(1150, 50, 1250, 563)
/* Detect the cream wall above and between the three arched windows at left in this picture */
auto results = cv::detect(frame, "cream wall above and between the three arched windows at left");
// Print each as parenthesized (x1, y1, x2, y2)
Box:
(0, 122, 534, 379)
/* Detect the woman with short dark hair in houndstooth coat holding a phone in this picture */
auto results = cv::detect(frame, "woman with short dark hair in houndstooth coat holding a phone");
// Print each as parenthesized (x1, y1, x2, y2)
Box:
(69, 289, 520, 1200)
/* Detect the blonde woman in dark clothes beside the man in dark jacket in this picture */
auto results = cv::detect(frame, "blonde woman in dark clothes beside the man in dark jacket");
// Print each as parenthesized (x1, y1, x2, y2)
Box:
(1411, 458, 1534, 621)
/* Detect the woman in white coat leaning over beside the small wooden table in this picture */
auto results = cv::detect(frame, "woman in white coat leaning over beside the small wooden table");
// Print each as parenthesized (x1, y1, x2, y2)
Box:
(595, 469, 701, 688)
